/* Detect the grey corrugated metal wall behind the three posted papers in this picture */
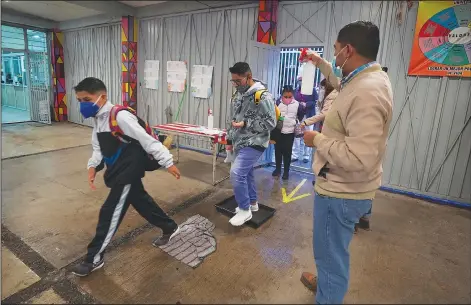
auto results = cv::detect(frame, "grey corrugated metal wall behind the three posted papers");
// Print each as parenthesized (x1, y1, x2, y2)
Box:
(138, 4, 258, 148)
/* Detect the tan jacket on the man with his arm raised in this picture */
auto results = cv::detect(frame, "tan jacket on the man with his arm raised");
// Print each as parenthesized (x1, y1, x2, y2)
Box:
(313, 60, 393, 199)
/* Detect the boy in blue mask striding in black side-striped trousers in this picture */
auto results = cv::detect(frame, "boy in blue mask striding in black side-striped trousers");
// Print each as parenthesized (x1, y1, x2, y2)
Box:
(72, 77, 180, 276)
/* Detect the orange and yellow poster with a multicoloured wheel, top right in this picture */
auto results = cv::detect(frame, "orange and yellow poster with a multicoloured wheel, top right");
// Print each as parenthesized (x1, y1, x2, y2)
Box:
(408, 1, 471, 77)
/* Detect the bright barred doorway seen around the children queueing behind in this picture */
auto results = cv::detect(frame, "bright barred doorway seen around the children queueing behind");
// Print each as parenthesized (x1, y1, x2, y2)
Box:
(270, 46, 324, 173)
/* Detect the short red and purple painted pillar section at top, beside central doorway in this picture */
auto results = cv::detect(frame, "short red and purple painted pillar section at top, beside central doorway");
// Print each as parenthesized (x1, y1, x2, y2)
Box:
(257, 0, 278, 46)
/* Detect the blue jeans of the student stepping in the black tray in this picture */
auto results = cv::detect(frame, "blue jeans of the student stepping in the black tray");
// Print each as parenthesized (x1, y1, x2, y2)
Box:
(231, 147, 263, 210)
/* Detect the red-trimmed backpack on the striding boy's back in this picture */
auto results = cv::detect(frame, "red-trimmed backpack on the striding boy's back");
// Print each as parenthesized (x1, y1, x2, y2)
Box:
(109, 105, 170, 172)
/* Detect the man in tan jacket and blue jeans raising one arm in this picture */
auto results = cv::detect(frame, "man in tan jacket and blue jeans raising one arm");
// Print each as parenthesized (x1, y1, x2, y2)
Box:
(301, 21, 393, 304)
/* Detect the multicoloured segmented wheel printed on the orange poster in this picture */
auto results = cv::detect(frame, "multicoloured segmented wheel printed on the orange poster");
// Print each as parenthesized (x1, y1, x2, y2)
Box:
(418, 2, 471, 66)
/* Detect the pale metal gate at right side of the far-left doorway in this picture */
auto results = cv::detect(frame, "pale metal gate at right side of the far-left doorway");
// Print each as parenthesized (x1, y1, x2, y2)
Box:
(28, 52, 51, 124)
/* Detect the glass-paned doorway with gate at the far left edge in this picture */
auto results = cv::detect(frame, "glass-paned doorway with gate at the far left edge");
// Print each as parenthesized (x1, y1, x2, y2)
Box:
(1, 24, 51, 124)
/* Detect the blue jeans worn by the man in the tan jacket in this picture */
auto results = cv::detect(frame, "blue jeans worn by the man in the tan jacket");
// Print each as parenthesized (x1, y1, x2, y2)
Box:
(313, 193, 372, 304)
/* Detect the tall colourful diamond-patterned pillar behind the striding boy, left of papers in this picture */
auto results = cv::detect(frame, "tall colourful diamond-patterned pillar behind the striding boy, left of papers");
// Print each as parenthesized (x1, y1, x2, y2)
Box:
(121, 16, 138, 110)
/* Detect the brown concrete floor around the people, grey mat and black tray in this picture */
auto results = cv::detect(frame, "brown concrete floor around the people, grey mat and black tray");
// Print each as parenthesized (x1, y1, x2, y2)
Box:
(2, 124, 471, 304)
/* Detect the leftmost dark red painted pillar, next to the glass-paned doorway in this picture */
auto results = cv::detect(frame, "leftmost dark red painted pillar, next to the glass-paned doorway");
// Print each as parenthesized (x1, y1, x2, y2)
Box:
(51, 31, 67, 122)
